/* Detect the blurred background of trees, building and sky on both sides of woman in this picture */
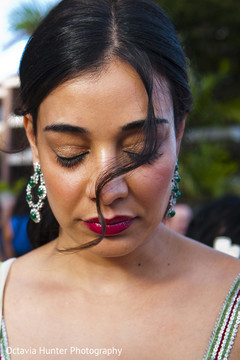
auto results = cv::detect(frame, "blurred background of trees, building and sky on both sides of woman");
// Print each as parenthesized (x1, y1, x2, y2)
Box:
(0, 0, 240, 258)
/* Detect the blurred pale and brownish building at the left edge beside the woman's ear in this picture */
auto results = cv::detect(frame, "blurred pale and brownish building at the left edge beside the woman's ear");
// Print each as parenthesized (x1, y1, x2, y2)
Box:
(0, 75, 32, 184)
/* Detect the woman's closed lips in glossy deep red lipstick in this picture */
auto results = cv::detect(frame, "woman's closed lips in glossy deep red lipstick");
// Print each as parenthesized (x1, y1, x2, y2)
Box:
(83, 216, 135, 236)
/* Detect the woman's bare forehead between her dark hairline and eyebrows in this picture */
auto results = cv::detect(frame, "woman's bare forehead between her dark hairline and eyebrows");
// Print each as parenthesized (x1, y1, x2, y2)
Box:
(39, 60, 173, 130)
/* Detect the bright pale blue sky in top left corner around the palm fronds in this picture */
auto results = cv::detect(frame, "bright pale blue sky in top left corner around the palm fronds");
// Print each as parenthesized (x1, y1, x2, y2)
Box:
(0, 0, 58, 81)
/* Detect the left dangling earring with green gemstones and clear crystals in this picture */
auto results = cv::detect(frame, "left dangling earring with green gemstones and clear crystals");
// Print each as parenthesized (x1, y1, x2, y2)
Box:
(26, 162, 47, 223)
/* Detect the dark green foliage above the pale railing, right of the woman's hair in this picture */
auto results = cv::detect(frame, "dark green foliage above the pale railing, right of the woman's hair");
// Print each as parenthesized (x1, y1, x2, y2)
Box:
(156, 0, 240, 125)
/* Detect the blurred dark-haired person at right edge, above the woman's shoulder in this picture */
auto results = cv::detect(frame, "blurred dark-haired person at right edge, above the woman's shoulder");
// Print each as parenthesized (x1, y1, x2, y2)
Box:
(186, 195, 240, 258)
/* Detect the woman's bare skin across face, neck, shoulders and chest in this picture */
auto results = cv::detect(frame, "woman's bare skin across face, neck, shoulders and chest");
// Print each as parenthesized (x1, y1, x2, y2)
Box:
(1, 59, 240, 360)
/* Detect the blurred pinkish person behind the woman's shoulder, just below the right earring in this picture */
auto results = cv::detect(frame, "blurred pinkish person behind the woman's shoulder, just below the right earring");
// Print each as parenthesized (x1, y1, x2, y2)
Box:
(165, 204, 193, 235)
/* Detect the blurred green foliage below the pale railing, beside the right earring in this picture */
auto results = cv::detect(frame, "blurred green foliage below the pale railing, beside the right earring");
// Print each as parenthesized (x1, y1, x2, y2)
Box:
(180, 142, 240, 202)
